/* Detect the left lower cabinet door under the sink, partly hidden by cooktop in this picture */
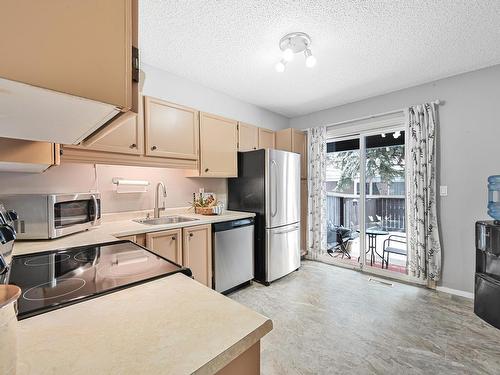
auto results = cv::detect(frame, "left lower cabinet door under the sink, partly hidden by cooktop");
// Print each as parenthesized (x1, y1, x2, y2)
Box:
(146, 229, 182, 264)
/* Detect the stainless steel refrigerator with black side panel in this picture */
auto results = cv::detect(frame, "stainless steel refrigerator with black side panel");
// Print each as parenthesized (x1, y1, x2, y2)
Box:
(228, 149, 300, 285)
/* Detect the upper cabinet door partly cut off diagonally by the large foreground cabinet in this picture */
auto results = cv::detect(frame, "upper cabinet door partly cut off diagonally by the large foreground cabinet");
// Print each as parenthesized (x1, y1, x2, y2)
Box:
(75, 110, 144, 155)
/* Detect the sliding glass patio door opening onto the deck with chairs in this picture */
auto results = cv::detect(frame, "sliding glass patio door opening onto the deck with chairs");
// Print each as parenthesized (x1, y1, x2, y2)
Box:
(324, 128, 408, 279)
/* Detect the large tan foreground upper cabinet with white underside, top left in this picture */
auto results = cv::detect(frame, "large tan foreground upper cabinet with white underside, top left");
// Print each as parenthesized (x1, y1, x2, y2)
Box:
(0, 0, 139, 144)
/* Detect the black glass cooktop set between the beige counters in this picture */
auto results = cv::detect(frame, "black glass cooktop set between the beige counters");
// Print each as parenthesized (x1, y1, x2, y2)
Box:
(9, 241, 191, 320)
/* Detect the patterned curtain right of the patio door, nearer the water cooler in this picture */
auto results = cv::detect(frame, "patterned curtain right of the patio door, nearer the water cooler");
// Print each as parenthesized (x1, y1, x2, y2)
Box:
(406, 103, 441, 281)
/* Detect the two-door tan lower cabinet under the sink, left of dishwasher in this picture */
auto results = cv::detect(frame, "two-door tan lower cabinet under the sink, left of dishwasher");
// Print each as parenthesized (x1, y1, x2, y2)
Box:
(126, 224, 212, 288)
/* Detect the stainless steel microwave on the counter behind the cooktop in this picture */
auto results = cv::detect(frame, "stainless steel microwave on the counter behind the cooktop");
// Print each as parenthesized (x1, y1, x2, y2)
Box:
(0, 193, 101, 240)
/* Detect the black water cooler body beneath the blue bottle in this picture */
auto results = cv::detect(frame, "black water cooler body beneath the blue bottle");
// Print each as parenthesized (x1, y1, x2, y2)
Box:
(474, 221, 500, 329)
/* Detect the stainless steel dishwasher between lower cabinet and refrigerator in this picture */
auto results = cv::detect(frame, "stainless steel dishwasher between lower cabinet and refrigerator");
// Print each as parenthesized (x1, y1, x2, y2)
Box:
(212, 218, 254, 293)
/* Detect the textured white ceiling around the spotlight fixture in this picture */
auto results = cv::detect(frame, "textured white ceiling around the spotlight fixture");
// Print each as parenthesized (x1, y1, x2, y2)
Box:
(140, 0, 500, 117)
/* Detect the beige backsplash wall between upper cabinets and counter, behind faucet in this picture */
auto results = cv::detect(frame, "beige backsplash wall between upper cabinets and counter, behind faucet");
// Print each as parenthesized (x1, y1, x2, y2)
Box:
(0, 164, 227, 213)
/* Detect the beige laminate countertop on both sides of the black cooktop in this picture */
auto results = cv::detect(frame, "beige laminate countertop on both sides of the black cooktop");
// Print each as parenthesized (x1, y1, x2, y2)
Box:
(10, 212, 273, 375)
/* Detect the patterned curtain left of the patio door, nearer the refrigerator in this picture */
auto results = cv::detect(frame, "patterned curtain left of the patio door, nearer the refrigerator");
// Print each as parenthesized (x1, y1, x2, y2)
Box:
(307, 126, 327, 259)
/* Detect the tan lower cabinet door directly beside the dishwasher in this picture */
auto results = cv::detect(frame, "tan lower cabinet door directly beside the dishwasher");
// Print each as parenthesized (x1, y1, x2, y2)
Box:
(183, 225, 212, 288)
